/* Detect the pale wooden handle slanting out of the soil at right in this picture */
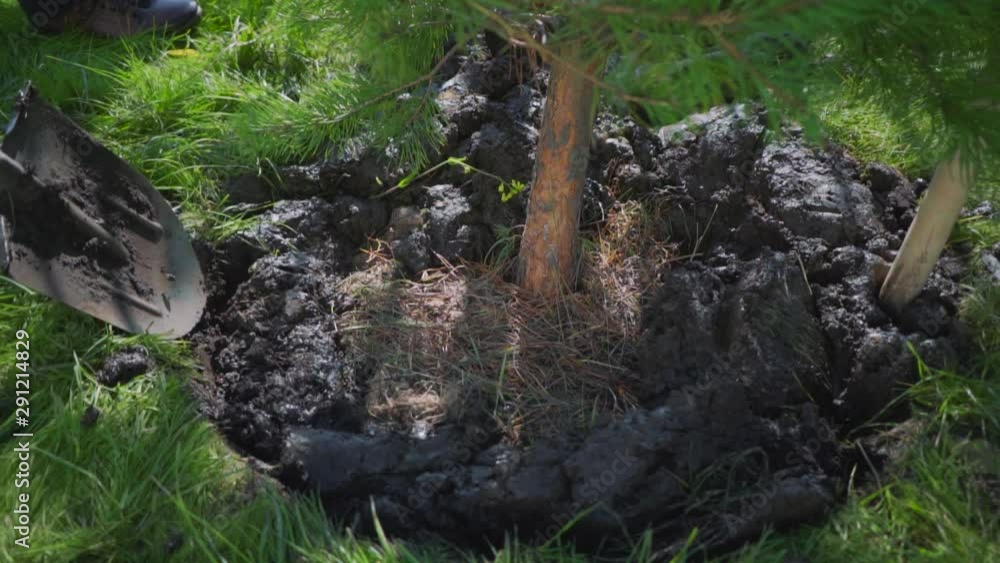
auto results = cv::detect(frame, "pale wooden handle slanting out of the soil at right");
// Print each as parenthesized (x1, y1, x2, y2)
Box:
(879, 152, 973, 311)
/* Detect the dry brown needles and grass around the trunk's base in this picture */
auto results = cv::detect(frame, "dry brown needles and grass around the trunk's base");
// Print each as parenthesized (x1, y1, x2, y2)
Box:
(340, 203, 672, 442)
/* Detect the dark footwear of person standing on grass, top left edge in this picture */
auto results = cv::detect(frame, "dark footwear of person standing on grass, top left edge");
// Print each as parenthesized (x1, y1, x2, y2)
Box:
(21, 0, 201, 37)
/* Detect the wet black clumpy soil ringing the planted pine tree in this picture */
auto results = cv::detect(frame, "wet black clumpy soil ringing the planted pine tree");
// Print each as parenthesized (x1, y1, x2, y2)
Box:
(195, 46, 965, 553)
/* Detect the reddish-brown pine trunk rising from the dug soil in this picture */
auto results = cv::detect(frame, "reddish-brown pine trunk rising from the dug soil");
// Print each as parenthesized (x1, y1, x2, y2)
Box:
(518, 51, 594, 297)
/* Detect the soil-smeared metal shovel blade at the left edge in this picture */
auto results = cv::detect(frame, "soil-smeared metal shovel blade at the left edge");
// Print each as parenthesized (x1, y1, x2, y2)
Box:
(0, 84, 205, 338)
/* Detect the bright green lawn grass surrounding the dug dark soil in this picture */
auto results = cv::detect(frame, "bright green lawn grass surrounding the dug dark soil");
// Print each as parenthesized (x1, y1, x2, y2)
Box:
(0, 0, 1000, 563)
